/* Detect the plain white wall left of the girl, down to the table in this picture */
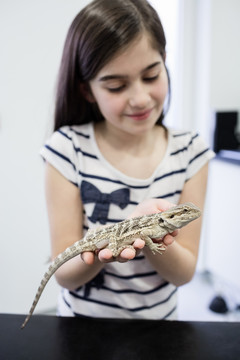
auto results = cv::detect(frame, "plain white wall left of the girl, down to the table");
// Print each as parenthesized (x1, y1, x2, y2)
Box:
(0, 0, 87, 313)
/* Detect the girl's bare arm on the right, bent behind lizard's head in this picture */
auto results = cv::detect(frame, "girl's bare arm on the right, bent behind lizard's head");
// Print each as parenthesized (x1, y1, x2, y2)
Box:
(144, 165, 208, 286)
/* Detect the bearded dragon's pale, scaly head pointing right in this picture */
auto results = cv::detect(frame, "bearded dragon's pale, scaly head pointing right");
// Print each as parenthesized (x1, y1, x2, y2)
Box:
(161, 203, 201, 228)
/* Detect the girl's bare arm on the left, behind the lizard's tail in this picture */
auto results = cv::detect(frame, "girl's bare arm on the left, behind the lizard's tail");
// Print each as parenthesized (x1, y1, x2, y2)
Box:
(45, 163, 103, 290)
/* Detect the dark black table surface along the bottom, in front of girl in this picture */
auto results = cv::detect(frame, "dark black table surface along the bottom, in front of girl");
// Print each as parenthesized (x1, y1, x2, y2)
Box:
(0, 314, 240, 360)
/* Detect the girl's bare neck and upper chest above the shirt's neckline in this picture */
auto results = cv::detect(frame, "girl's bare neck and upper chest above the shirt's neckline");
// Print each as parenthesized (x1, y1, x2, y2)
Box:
(95, 123, 167, 179)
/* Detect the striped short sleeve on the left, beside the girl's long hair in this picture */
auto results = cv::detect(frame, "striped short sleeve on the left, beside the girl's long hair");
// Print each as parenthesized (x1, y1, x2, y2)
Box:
(40, 127, 78, 186)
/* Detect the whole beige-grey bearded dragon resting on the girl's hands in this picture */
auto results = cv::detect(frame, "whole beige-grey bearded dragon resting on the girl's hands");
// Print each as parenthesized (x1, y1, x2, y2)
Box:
(21, 203, 201, 329)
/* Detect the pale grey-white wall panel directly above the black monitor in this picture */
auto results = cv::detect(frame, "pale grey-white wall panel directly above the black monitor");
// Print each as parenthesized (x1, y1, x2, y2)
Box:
(210, 0, 240, 110)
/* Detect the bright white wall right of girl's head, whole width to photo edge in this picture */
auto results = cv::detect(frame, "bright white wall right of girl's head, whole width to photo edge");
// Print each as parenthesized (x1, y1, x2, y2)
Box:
(179, 0, 240, 139)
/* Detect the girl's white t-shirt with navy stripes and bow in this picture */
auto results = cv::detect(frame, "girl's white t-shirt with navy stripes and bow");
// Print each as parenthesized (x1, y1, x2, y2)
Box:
(41, 123, 214, 319)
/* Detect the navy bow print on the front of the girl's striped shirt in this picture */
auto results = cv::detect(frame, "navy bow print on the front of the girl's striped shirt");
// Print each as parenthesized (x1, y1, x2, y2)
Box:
(81, 181, 129, 224)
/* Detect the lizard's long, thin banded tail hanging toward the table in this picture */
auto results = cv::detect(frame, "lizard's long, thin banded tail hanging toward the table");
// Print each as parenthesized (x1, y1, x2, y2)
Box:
(21, 240, 83, 329)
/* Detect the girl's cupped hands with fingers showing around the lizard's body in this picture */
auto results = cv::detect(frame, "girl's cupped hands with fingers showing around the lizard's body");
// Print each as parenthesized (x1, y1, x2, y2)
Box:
(82, 199, 178, 265)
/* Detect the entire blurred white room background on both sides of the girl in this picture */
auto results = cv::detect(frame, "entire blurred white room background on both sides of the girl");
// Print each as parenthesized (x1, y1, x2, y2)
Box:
(0, 0, 240, 321)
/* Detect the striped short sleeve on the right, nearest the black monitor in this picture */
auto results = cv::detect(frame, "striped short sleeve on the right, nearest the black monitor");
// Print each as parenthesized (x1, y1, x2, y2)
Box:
(186, 133, 215, 180)
